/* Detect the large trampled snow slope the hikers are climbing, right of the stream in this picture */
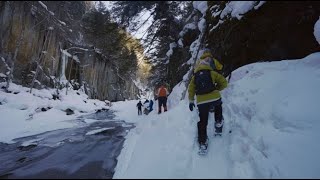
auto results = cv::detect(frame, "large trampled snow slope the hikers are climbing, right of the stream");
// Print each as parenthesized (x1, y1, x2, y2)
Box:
(112, 53, 320, 179)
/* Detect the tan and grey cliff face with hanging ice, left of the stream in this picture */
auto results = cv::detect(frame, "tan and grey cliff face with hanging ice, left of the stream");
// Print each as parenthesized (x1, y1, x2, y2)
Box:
(0, 1, 138, 101)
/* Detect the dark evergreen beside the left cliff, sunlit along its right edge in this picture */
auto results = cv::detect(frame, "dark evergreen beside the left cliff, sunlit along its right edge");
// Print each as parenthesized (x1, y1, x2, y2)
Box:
(82, 2, 137, 74)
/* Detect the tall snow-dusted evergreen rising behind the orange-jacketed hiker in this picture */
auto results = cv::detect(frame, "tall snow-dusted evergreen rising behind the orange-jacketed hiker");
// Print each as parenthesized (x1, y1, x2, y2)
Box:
(112, 1, 192, 85)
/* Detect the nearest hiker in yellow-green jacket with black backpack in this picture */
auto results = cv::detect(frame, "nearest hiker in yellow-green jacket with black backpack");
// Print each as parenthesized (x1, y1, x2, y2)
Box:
(188, 50, 228, 152)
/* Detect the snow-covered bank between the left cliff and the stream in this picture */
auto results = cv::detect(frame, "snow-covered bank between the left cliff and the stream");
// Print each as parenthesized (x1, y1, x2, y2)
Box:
(0, 83, 109, 143)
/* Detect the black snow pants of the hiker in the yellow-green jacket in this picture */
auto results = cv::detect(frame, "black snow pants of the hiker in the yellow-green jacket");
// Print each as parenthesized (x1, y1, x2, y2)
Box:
(197, 99, 222, 143)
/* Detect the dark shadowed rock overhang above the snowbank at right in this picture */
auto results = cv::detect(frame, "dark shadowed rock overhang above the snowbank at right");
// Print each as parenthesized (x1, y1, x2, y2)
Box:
(205, 1, 320, 74)
